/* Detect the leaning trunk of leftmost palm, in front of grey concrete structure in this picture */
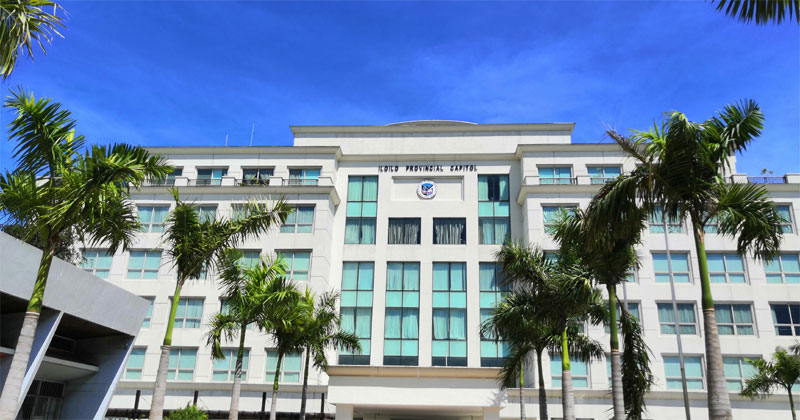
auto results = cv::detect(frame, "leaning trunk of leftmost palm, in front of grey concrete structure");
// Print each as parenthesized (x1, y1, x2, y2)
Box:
(0, 242, 56, 419)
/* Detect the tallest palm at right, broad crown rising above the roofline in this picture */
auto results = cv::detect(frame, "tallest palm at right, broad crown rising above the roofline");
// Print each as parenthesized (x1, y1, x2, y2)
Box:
(588, 100, 782, 419)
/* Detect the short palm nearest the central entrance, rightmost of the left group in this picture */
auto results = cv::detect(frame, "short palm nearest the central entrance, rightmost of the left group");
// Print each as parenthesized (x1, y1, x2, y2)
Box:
(300, 289, 361, 420)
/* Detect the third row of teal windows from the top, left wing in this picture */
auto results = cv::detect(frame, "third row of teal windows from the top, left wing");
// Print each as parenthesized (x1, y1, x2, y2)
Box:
(81, 249, 311, 281)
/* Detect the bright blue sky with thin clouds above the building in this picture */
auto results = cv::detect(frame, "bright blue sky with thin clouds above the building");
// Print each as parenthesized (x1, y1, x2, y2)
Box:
(0, 1, 800, 174)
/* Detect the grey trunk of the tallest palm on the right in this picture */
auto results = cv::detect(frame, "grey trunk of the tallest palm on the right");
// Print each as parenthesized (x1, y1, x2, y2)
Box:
(692, 223, 733, 420)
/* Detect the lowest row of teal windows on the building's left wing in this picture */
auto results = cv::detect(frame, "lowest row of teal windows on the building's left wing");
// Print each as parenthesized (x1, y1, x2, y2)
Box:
(124, 347, 303, 383)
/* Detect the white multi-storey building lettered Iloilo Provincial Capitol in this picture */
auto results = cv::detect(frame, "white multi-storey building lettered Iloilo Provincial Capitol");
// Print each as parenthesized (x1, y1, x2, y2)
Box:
(85, 121, 800, 420)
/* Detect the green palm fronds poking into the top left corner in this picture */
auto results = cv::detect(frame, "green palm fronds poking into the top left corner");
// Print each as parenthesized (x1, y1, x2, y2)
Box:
(0, 0, 64, 80)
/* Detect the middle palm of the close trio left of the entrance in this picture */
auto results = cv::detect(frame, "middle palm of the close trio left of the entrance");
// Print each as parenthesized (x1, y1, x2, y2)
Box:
(258, 277, 306, 420)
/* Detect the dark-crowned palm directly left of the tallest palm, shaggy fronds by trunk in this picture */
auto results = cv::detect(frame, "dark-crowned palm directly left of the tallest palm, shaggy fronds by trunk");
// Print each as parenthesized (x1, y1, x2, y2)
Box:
(553, 206, 652, 420)
